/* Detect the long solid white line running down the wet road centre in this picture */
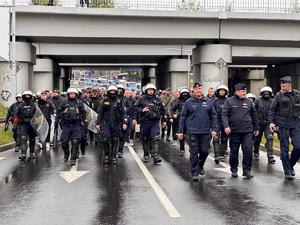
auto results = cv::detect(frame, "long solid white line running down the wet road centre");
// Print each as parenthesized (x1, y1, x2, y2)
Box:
(127, 146, 181, 218)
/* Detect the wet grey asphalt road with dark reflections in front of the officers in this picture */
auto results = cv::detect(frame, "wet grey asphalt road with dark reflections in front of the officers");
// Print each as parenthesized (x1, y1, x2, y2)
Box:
(0, 142, 300, 225)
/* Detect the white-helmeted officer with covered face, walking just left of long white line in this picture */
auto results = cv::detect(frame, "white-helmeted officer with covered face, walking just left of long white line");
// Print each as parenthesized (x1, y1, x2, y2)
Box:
(96, 85, 128, 164)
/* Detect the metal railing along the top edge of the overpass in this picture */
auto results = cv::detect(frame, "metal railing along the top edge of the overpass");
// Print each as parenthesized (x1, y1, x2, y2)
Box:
(0, 0, 300, 14)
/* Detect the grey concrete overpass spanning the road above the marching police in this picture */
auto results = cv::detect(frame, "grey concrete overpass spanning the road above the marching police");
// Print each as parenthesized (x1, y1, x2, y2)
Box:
(1, 6, 300, 104)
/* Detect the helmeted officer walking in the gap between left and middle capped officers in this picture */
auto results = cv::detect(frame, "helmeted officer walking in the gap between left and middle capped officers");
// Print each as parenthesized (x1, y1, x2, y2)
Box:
(213, 84, 228, 164)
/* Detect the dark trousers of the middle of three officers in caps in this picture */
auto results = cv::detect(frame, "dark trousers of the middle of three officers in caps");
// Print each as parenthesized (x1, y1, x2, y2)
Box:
(229, 132, 253, 173)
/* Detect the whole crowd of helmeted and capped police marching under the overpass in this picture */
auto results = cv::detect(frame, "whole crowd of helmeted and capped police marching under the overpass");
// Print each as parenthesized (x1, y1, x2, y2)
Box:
(5, 76, 300, 181)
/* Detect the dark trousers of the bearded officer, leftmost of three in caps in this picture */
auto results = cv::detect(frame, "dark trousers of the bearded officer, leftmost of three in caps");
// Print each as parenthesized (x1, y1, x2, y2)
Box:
(188, 134, 210, 176)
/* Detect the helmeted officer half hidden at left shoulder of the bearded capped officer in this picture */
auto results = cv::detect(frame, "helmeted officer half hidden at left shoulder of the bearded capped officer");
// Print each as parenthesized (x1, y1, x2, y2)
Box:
(171, 88, 191, 156)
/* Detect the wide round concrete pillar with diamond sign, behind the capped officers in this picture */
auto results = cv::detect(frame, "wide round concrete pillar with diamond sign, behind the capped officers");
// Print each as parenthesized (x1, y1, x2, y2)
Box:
(193, 44, 232, 94)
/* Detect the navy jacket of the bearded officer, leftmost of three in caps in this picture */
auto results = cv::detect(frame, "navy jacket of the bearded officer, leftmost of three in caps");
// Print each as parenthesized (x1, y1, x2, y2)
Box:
(178, 97, 219, 134)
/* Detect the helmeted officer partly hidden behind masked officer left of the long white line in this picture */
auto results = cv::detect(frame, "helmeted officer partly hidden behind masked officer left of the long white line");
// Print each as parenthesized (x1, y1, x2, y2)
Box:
(117, 84, 133, 158)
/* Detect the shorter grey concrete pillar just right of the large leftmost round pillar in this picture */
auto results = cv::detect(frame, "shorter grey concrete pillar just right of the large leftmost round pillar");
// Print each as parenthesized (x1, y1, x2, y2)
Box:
(33, 59, 54, 91)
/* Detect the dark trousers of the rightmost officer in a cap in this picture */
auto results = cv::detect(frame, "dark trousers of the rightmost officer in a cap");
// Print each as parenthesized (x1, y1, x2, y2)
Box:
(279, 127, 300, 174)
